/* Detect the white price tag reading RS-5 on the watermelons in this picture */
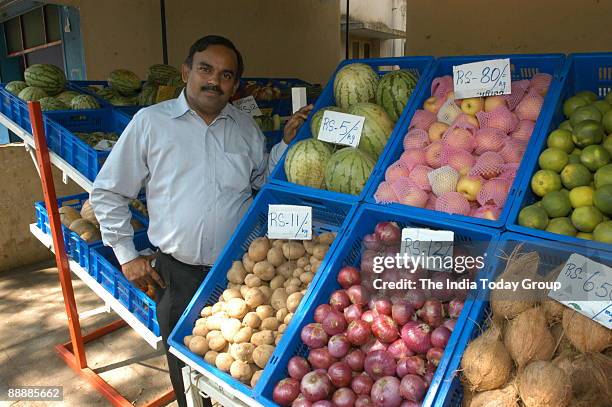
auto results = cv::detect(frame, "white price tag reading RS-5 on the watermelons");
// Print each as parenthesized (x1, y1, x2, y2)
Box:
(318, 110, 365, 147)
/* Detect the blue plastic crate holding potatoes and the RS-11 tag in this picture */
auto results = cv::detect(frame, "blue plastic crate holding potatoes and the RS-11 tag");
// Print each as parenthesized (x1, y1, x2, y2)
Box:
(168, 184, 354, 404)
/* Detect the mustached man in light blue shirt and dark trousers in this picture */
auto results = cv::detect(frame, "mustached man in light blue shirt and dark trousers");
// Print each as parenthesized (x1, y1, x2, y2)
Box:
(91, 36, 312, 406)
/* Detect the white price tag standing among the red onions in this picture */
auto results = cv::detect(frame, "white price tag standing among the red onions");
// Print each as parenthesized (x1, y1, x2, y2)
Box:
(400, 228, 455, 271)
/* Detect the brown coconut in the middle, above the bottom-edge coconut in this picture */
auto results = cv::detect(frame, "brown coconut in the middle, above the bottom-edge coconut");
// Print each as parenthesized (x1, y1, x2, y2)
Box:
(504, 307, 556, 369)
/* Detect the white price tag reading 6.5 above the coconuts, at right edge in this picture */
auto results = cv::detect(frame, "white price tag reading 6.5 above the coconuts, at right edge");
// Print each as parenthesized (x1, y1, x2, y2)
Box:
(548, 253, 612, 329)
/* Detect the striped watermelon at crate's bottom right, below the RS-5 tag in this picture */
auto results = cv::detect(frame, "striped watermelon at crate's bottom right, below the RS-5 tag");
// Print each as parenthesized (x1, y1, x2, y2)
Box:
(325, 147, 376, 195)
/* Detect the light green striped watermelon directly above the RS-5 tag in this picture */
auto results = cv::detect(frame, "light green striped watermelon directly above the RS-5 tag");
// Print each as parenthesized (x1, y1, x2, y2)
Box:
(334, 63, 378, 110)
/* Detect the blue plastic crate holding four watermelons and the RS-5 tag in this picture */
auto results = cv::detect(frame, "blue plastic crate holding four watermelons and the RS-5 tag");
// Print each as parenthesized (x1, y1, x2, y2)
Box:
(269, 56, 434, 202)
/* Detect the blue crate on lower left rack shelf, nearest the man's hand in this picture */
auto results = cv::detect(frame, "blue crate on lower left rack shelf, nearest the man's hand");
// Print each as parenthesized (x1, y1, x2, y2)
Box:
(90, 233, 160, 335)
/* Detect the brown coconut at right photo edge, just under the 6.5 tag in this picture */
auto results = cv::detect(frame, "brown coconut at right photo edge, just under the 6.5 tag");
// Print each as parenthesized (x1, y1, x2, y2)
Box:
(562, 308, 612, 353)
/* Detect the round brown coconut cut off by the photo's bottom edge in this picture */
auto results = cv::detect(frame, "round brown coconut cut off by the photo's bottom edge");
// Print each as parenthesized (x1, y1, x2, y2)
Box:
(517, 360, 572, 407)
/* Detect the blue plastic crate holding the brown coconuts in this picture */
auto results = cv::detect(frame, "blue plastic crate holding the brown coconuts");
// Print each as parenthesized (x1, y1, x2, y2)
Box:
(433, 232, 612, 407)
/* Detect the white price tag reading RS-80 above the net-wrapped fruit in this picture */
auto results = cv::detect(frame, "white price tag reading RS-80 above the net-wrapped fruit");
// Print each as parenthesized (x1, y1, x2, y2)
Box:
(453, 58, 512, 99)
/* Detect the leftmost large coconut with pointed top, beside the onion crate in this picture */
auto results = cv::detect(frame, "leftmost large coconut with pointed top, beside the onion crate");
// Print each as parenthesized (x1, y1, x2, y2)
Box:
(461, 325, 512, 391)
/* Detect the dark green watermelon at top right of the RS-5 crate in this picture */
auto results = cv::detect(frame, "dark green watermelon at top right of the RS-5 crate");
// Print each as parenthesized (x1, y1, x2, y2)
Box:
(376, 70, 418, 122)
